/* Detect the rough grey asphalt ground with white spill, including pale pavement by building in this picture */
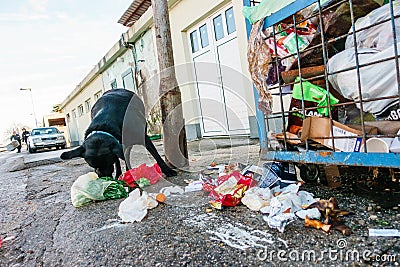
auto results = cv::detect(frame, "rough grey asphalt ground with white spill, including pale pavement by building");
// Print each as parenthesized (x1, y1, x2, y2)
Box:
(0, 140, 400, 266)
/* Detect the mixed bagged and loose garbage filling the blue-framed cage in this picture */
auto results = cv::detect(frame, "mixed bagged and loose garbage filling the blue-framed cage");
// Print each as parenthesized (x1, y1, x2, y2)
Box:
(243, 0, 400, 156)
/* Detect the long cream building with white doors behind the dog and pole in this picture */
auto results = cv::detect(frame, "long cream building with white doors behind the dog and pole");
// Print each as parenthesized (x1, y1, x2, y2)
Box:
(61, 0, 257, 145)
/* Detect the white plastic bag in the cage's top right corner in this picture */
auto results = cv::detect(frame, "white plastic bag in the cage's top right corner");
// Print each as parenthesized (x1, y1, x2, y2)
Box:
(346, 1, 400, 51)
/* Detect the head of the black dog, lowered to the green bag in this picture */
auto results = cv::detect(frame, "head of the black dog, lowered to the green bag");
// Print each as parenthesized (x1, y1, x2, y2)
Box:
(60, 134, 124, 177)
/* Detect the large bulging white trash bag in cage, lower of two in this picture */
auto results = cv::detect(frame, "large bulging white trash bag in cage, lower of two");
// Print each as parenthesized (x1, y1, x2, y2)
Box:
(328, 43, 400, 118)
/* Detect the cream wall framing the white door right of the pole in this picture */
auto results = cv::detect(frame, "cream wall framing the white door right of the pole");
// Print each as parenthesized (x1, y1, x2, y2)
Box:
(170, 0, 257, 136)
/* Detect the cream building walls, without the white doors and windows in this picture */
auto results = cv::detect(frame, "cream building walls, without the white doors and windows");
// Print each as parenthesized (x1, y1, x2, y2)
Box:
(62, 0, 257, 145)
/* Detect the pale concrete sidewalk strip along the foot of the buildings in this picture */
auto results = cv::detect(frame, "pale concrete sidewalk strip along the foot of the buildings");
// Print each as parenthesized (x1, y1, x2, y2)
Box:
(0, 137, 259, 172)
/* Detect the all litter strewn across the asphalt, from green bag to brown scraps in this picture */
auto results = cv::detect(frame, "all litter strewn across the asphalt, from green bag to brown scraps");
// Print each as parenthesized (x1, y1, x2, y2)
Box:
(71, 159, 351, 235)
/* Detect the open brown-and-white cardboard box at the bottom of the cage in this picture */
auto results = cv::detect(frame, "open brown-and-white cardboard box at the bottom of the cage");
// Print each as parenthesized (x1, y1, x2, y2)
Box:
(300, 117, 377, 152)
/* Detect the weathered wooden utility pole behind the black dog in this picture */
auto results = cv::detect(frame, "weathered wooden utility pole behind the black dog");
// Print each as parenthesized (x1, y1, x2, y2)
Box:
(151, 0, 189, 168)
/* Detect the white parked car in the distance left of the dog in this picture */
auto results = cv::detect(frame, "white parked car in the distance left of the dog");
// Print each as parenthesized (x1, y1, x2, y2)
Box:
(27, 127, 67, 153)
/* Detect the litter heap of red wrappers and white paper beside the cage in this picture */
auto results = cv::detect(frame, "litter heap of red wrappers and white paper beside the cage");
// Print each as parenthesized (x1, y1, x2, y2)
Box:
(199, 162, 352, 235)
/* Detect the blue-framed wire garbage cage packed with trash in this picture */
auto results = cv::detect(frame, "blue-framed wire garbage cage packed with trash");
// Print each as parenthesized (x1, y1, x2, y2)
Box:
(243, 0, 400, 180)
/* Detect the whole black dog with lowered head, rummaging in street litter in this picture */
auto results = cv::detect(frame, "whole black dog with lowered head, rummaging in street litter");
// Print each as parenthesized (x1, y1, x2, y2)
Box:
(60, 89, 177, 177)
